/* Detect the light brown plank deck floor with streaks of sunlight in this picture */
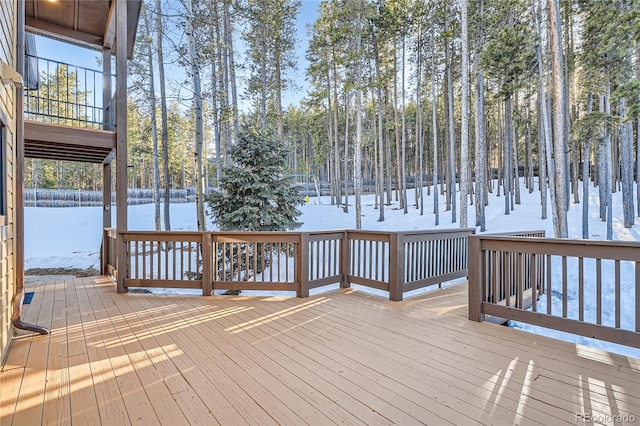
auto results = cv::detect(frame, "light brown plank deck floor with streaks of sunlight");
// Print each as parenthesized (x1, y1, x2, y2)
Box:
(0, 277, 640, 426)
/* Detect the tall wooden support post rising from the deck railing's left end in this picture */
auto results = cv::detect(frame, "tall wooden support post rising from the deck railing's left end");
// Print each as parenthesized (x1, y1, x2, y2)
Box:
(116, 0, 128, 293)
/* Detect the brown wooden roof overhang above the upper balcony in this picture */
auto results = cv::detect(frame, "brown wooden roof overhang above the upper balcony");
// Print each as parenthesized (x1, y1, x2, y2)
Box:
(25, 0, 142, 58)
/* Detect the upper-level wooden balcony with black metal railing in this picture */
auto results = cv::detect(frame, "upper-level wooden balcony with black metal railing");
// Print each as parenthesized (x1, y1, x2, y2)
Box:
(24, 55, 116, 163)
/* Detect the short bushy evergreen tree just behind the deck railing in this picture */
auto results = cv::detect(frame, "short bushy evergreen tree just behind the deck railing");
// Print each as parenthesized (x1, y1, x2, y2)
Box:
(207, 125, 303, 231)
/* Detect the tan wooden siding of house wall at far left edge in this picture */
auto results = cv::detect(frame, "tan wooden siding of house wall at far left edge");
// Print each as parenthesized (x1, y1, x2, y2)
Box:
(0, 1, 17, 360)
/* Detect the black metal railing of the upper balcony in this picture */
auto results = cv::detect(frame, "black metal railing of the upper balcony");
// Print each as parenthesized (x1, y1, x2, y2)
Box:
(24, 55, 115, 130)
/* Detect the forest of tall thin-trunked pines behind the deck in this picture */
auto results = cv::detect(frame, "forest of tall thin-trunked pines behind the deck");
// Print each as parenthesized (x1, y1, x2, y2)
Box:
(26, 0, 640, 239)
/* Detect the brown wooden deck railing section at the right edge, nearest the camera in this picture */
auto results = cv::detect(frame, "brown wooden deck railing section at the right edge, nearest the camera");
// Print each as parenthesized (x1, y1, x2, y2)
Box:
(469, 235, 640, 347)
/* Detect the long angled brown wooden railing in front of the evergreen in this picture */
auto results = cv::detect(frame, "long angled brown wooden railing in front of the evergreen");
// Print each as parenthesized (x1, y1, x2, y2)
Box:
(103, 229, 474, 300)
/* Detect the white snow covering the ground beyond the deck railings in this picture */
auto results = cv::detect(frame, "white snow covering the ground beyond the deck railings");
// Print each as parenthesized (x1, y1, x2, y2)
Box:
(25, 183, 640, 358)
